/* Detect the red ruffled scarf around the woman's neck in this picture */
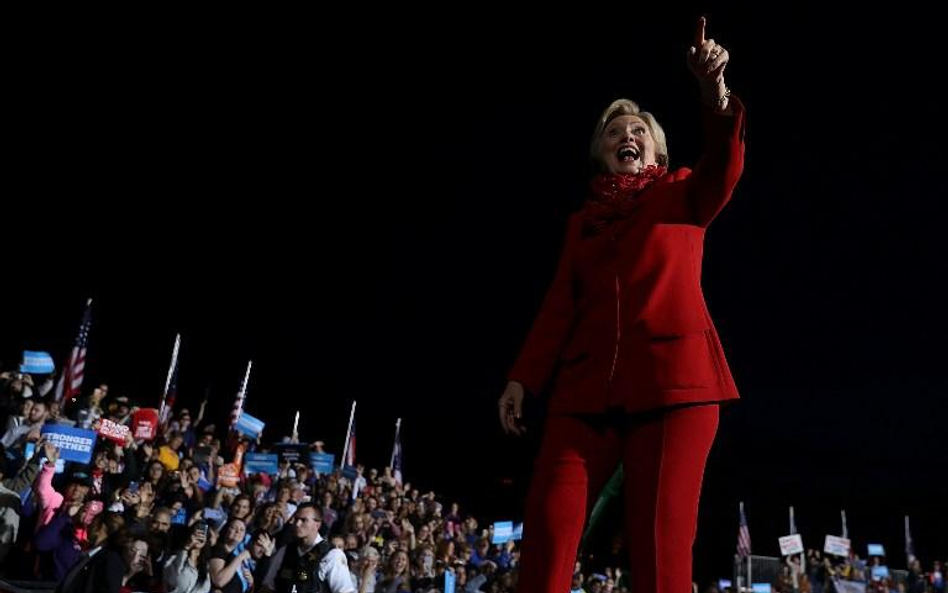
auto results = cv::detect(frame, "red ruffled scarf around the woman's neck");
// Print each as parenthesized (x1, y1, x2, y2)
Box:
(583, 165, 668, 235)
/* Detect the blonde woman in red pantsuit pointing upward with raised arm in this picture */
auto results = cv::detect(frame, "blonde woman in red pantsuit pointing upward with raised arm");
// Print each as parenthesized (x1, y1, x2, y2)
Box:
(499, 18, 744, 593)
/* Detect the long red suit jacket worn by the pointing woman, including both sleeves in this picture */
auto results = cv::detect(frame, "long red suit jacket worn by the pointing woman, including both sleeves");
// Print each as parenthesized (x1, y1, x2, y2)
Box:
(508, 97, 744, 414)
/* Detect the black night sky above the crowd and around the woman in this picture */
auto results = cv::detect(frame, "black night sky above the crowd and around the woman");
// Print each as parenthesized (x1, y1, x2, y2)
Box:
(0, 3, 948, 578)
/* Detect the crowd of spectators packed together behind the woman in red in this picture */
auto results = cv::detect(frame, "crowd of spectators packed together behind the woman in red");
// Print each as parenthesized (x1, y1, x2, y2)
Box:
(0, 372, 945, 593)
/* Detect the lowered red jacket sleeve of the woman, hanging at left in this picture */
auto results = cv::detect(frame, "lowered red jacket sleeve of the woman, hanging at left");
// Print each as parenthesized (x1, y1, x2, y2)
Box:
(507, 214, 581, 395)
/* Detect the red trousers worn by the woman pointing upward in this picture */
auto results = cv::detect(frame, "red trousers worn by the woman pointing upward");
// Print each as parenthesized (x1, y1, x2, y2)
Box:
(518, 404, 718, 593)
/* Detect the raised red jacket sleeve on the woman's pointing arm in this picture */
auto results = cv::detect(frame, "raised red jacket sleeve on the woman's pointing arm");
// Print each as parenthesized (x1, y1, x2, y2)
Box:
(688, 96, 744, 227)
